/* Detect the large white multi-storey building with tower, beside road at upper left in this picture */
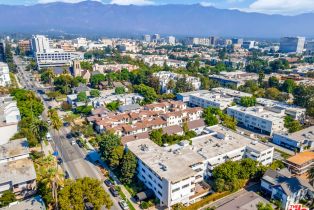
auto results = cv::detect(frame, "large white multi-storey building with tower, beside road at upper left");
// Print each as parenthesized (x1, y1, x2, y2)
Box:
(31, 35, 84, 68)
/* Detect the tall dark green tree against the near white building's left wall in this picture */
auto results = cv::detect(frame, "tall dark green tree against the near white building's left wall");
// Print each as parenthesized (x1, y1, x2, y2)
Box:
(120, 151, 137, 184)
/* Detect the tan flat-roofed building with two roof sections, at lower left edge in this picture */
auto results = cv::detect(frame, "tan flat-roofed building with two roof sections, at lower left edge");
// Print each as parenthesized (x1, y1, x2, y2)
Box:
(0, 139, 36, 198)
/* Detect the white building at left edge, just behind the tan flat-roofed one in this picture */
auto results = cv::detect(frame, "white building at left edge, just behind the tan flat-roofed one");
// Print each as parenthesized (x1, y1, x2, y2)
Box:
(0, 97, 21, 145)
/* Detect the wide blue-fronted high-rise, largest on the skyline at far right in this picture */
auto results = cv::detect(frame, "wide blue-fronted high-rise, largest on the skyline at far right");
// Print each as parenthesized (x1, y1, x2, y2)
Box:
(279, 37, 305, 53)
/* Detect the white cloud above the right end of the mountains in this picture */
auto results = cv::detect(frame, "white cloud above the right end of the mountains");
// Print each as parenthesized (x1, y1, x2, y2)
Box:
(247, 0, 314, 15)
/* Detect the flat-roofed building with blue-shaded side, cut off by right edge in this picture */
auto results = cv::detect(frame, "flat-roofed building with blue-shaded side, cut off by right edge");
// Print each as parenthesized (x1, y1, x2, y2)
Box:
(272, 126, 314, 152)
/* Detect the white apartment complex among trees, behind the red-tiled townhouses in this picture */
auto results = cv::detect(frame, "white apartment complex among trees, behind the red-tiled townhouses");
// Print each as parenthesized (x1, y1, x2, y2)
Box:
(153, 71, 201, 93)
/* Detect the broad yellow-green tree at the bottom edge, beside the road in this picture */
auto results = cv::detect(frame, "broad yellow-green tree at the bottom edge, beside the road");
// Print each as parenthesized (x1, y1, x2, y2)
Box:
(59, 177, 113, 210)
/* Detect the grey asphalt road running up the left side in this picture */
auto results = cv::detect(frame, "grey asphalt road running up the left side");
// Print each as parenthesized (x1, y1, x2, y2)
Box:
(14, 56, 121, 210)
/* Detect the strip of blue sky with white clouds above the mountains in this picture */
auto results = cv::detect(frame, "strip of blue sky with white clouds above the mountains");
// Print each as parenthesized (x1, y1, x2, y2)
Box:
(0, 0, 314, 15)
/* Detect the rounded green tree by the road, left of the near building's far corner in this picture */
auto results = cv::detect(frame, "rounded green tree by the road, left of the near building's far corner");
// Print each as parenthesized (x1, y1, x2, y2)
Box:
(99, 133, 121, 161)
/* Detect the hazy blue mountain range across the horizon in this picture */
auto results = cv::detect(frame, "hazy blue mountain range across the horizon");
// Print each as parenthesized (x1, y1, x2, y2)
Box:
(0, 1, 314, 38)
